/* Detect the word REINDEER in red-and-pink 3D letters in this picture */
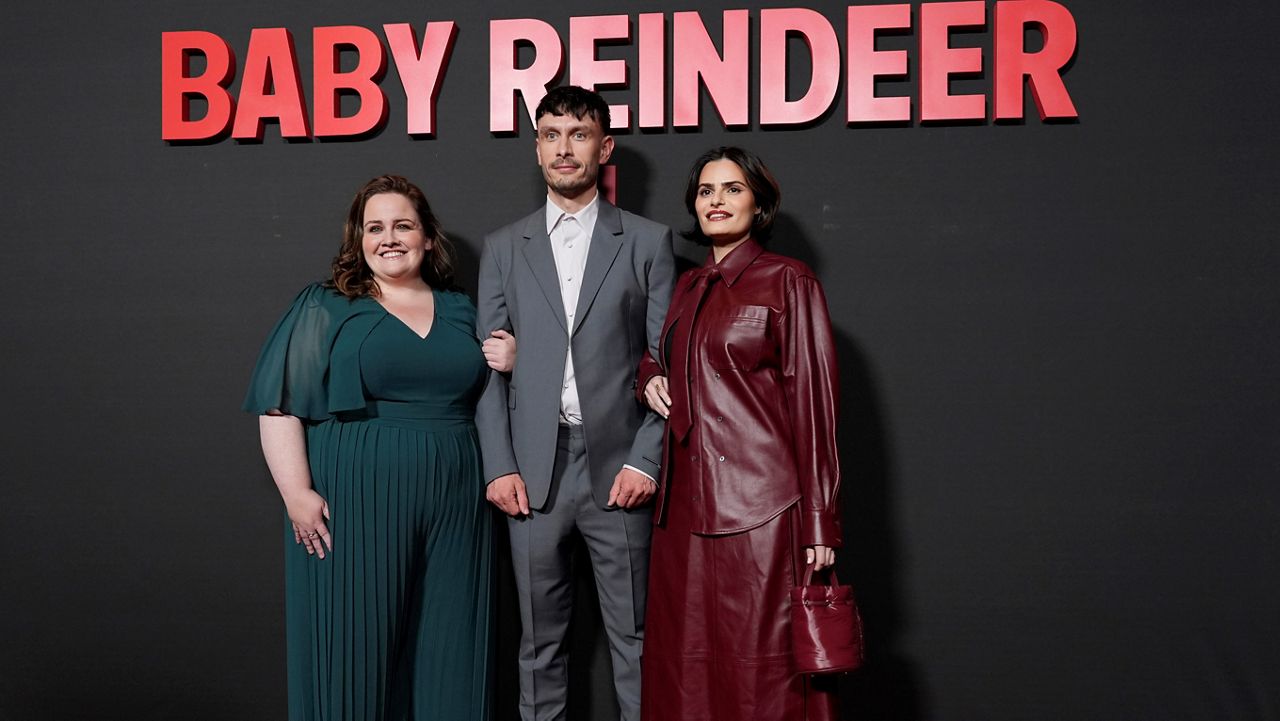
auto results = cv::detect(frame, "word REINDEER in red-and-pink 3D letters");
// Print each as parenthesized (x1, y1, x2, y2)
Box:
(489, 0, 1078, 133)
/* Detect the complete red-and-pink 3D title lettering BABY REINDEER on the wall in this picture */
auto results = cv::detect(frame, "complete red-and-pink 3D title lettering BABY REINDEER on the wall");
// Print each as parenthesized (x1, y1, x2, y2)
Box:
(160, 0, 1078, 142)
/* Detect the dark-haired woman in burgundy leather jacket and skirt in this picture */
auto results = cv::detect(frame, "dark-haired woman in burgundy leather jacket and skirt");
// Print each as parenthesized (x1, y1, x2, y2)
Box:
(637, 147, 841, 721)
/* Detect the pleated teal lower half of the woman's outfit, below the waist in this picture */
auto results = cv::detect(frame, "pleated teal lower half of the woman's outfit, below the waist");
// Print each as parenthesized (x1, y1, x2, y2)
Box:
(285, 419, 492, 721)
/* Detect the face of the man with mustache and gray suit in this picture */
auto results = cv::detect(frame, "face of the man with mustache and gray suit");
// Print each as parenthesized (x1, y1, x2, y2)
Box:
(538, 113, 613, 205)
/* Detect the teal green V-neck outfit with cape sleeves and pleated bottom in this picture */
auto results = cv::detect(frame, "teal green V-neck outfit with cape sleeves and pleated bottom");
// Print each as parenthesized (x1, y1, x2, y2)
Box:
(244, 284, 492, 721)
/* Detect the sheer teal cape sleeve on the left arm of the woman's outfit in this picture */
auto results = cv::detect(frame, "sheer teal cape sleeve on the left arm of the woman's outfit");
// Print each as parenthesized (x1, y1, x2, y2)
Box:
(241, 283, 365, 421)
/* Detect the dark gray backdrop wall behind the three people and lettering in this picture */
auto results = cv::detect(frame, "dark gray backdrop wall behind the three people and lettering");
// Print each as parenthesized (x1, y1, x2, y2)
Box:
(0, 0, 1280, 721)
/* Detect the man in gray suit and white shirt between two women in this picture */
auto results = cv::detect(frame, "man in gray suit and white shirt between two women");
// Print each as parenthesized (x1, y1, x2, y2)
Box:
(476, 86, 675, 721)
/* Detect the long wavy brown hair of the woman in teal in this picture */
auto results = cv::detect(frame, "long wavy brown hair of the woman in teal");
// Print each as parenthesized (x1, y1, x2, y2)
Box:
(329, 175, 453, 298)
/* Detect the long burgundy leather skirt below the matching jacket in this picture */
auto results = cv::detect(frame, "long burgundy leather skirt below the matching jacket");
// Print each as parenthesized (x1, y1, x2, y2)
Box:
(640, 443, 836, 721)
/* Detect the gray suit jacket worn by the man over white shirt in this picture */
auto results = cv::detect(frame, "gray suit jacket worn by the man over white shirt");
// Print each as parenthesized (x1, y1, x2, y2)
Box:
(476, 197, 675, 508)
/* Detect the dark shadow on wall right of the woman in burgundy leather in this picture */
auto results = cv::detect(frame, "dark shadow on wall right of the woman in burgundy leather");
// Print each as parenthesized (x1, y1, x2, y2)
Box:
(768, 214, 929, 721)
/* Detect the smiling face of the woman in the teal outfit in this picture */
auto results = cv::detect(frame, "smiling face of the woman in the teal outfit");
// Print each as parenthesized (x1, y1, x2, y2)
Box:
(361, 193, 433, 290)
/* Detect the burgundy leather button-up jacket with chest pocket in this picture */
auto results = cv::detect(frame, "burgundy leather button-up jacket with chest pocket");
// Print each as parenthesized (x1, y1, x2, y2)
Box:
(636, 241, 841, 547)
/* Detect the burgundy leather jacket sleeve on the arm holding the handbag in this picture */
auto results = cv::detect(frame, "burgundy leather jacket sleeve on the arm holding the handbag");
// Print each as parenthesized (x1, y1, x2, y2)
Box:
(782, 275, 842, 547)
